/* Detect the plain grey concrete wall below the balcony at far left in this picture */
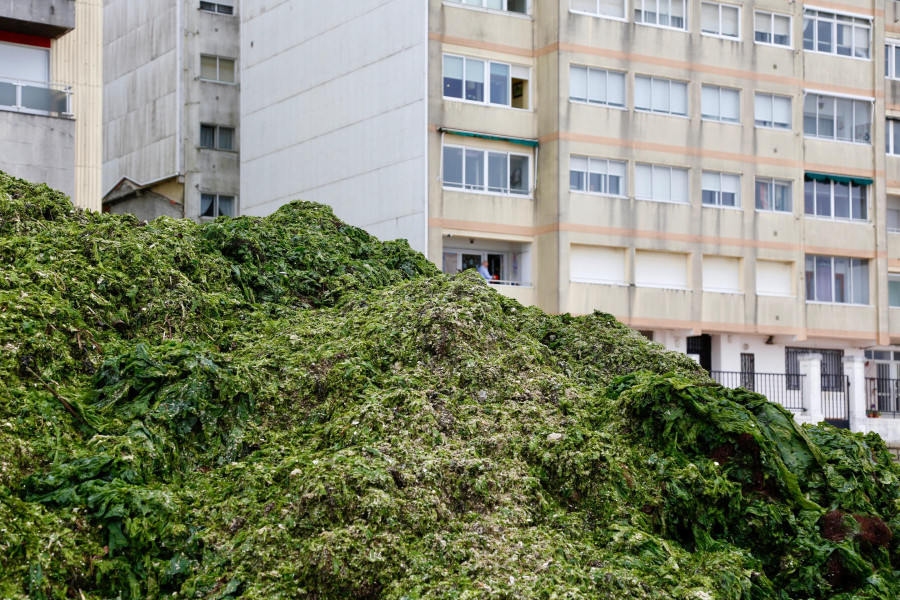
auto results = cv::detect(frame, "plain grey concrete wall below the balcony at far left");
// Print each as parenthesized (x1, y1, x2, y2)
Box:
(0, 111, 75, 196)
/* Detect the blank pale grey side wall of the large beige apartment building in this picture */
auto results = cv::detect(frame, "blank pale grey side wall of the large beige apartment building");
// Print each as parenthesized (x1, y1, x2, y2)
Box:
(241, 0, 428, 250)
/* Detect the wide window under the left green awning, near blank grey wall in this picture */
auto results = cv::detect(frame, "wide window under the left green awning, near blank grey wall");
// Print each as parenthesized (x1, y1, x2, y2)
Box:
(443, 146, 531, 195)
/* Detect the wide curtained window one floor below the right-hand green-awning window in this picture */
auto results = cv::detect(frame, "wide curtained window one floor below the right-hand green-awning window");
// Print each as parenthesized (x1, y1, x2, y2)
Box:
(806, 254, 869, 304)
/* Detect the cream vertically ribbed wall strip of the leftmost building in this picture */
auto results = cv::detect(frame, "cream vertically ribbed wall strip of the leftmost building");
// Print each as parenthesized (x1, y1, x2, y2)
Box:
(51, 0, 103, 211)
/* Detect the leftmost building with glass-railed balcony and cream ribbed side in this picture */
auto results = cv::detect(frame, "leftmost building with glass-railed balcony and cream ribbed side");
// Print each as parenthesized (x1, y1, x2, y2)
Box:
(0, 0, 102, 209)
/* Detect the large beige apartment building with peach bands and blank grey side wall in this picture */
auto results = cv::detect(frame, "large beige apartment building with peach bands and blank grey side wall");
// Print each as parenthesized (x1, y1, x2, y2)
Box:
(241, 0, 900, 422)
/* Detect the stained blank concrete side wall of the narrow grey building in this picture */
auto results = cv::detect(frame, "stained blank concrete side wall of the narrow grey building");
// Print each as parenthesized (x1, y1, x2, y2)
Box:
(103, 0, 178, 194)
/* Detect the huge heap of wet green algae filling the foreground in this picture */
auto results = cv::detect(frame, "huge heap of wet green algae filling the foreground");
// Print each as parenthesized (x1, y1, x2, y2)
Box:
(0, 175, 900, 600)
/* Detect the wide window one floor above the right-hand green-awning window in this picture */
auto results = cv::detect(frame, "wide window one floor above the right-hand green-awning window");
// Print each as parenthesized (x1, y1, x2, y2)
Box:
(803, 92, 872, 144)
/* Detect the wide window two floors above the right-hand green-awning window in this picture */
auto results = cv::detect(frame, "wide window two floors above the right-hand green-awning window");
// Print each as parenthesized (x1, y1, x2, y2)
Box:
(803, 9, 872, 58)
